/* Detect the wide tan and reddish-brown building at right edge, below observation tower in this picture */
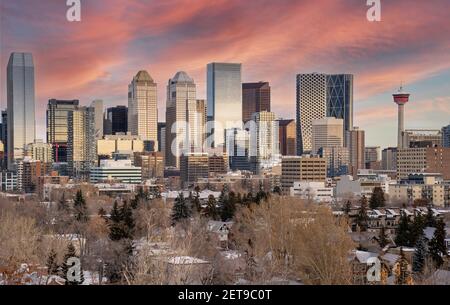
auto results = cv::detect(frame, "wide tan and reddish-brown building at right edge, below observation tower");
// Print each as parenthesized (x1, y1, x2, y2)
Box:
(397, 147, 450, 180)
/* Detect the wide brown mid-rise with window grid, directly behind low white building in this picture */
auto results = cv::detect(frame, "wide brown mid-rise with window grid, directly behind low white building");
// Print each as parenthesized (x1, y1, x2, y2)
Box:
(281, 155, 327, 194)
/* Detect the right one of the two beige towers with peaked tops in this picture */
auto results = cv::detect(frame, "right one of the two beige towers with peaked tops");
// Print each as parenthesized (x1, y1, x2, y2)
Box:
(165, 71, 206, 168)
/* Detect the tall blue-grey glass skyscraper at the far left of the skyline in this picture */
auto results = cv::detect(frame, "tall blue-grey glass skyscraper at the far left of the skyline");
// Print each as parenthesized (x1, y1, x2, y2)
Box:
(6, 53, 36, 170)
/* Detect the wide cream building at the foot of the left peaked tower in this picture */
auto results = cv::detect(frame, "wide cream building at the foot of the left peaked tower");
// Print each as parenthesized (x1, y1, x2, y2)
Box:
(97, 133, 144, 157)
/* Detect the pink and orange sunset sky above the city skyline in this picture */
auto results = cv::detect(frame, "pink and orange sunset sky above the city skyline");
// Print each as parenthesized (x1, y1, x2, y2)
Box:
(0, 0, 450, 147)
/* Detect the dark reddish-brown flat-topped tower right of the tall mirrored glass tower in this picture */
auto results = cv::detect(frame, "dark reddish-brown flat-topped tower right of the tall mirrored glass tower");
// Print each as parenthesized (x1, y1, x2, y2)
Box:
(242, 82, 270, 123)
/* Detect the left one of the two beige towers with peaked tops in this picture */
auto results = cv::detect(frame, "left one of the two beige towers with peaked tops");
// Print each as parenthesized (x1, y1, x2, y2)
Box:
(128, 71, 158, 151)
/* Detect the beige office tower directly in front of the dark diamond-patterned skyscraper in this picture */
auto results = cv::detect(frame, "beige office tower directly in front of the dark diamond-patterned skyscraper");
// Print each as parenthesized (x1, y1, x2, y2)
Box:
(311, 118, 344, 154)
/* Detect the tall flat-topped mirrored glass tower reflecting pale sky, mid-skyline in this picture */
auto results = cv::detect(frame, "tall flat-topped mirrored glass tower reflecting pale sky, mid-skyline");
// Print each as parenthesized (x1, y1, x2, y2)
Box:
(207, 63, 242, 147)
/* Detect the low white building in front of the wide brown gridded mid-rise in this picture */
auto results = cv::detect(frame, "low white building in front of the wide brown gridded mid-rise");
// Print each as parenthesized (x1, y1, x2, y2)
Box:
(290, 181, 333, 203)
